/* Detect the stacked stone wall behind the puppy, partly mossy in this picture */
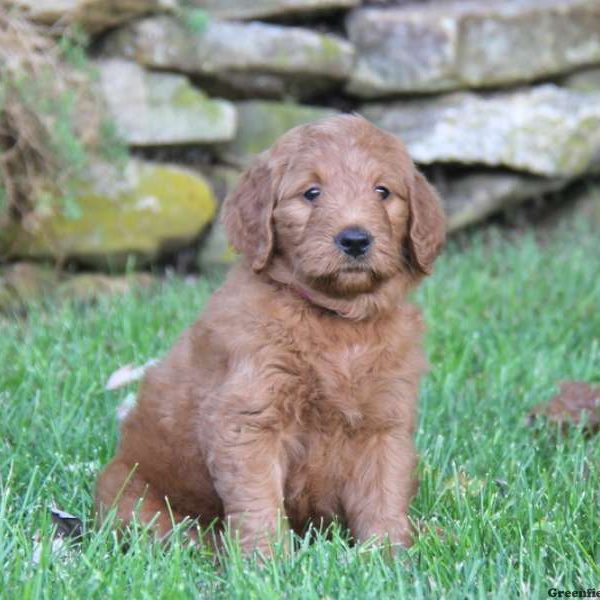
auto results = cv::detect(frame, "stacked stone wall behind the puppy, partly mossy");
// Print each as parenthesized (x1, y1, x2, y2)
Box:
(1, 0, 600, 284)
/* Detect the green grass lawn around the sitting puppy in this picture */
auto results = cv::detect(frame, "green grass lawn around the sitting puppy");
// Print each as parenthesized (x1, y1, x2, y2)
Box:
(0, 227, 600, 600)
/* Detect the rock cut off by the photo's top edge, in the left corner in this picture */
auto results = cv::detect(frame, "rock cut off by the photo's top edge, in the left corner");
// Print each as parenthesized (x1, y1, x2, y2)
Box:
(6, 0, 177, 33)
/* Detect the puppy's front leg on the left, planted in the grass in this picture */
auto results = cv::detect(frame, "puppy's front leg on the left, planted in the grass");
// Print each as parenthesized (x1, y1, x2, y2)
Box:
(209, 427, 288, 554)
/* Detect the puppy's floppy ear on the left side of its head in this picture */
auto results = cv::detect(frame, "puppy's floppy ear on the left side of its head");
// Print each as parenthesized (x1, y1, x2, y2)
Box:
(221, 157, 275, 272)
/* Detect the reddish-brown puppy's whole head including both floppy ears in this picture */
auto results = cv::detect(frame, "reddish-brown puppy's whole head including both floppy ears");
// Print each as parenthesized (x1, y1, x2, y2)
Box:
(223, 115, 445, 296)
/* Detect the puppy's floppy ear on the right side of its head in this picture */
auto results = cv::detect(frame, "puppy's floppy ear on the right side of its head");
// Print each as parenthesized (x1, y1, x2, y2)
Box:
(408, 172, 446, 275)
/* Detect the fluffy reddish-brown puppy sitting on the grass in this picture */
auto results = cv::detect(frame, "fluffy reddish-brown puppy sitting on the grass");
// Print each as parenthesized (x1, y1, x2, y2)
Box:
(96, 115, 445, 551)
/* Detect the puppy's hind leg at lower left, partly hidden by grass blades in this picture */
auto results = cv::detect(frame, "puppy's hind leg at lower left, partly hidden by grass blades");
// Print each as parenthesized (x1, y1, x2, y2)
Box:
(96, 460, 194, 538)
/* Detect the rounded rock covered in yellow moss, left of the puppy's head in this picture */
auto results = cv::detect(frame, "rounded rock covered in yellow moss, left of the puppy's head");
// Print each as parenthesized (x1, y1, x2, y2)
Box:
(8, 160, 217, 269)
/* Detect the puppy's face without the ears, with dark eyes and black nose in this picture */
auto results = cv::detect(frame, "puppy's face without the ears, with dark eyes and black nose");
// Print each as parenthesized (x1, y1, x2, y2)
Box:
(273, 119, 412, 294)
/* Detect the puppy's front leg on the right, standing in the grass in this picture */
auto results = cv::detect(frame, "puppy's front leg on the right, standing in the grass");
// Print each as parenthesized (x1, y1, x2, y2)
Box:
(342, 431, 416, 547)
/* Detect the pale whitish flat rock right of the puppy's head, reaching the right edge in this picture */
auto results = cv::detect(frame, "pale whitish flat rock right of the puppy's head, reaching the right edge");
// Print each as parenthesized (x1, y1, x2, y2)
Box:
(361, 85, 600, 177)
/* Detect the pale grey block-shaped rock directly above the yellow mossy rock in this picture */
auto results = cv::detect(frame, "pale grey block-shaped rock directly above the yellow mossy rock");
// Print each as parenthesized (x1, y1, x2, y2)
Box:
(97, 59, 236, 146)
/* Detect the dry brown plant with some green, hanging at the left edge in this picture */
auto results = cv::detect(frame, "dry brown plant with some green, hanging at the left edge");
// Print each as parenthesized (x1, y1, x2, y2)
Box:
(0, 11, 123, 224)
